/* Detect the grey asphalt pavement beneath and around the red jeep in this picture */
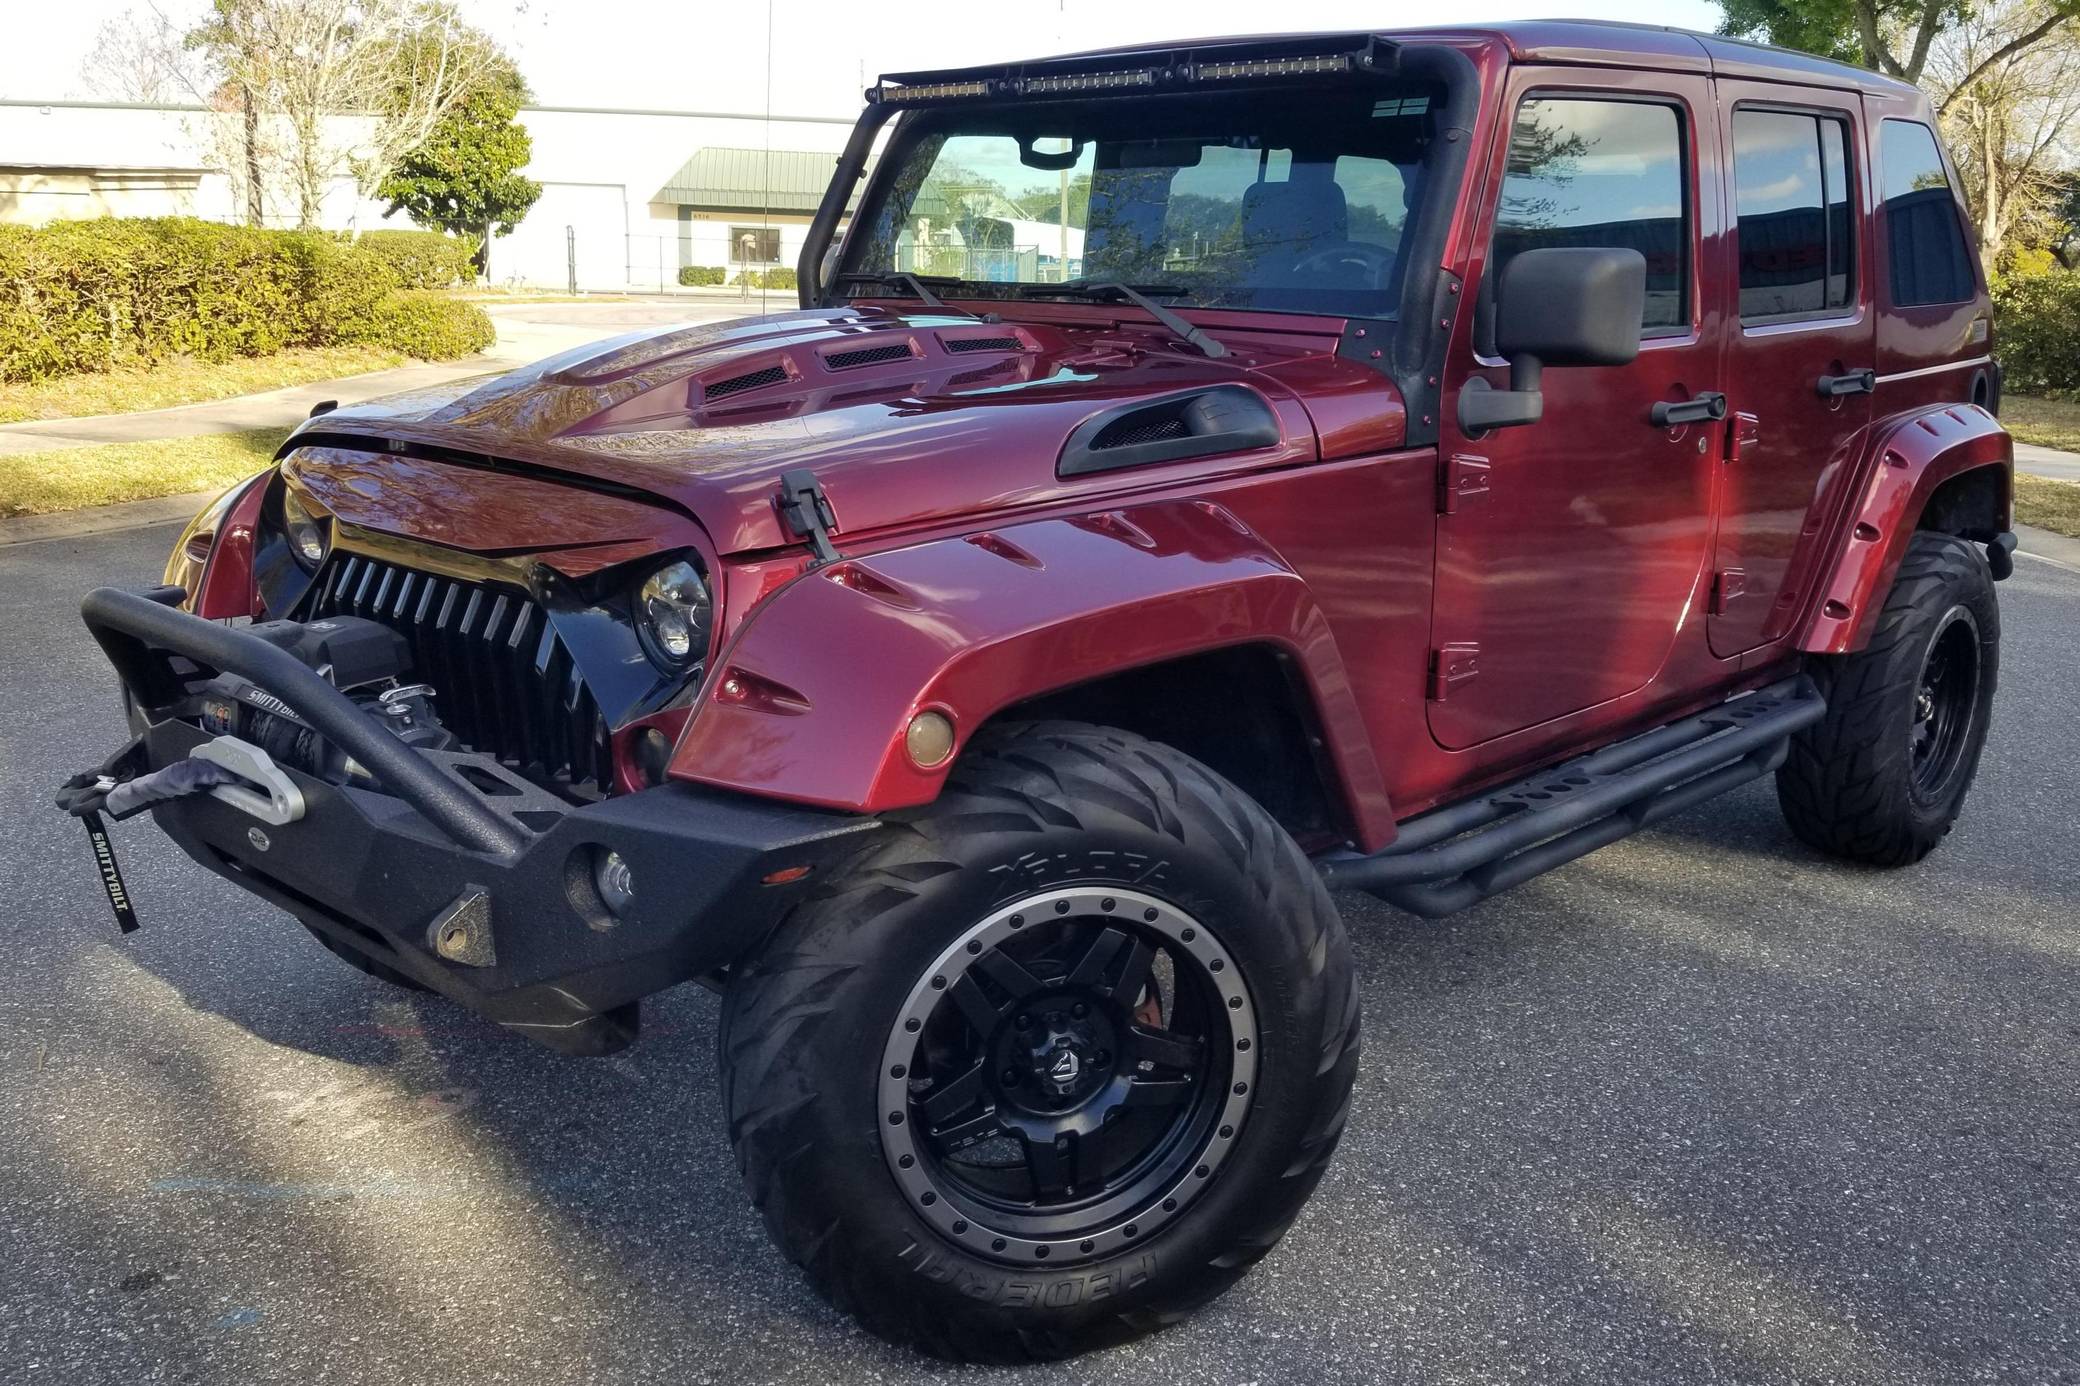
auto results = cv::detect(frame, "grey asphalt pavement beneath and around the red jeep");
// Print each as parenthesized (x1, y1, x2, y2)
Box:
(0, 527, 2080, 1386)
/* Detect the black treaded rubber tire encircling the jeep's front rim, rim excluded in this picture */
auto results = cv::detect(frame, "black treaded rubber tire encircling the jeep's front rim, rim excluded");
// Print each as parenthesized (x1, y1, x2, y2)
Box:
(722, 722, 1358, 1361)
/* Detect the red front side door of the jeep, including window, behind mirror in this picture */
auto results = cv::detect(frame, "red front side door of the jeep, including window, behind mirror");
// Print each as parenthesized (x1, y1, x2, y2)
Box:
(1429, 69, 1724, 749)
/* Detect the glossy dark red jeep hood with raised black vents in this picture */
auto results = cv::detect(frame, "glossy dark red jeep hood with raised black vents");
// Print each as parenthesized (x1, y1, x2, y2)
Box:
(295, 308, 1392, 554)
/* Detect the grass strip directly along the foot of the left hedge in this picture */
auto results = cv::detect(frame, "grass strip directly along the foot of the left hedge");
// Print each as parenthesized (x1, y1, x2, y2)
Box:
(0, 345, 406, 422)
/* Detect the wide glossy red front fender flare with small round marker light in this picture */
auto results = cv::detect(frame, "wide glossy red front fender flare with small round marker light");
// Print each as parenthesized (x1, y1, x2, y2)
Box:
(670, 499, 1394, 839)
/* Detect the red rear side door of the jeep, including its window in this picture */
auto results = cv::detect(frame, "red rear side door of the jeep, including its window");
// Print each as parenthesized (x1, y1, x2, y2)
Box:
(1708, 81, 1876, 656)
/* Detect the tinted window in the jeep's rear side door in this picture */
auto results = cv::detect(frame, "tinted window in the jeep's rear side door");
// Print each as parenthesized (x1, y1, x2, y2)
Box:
(1733, 110, 1855, 320)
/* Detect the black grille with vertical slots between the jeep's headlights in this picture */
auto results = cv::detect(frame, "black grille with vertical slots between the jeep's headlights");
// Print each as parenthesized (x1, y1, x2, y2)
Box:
(304, 554, 614, 797)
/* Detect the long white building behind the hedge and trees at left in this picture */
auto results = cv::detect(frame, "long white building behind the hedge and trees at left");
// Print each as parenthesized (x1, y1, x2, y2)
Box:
(0, 100, 851, 291)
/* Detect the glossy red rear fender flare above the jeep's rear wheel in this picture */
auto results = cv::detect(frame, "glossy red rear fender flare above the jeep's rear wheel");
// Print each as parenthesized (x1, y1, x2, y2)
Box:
(1797, 404, 2016, 653)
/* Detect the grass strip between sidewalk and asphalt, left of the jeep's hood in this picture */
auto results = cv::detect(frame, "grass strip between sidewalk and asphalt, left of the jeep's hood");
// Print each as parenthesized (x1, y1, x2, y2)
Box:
(0, 429, 289, 518)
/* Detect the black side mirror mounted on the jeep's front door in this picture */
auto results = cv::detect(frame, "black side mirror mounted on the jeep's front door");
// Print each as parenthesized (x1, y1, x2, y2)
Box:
(1458, 246, 1647, 435)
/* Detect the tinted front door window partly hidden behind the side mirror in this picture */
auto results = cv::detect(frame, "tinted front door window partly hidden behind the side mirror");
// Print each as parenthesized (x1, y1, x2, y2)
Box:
(1487, 98, 1691, 331)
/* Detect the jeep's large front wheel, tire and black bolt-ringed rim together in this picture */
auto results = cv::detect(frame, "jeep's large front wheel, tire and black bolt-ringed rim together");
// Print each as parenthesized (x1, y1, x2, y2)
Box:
(722, 724, 1358, 1361)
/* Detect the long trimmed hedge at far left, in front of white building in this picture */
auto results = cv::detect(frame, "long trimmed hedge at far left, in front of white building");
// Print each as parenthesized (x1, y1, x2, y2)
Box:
(0, 216, 491, 381)
